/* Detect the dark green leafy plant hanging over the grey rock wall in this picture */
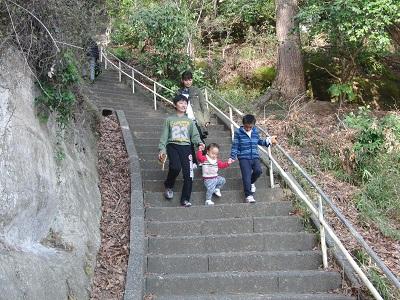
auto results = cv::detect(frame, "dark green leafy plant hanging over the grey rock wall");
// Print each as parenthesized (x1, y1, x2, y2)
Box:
(35, 52, 81, 128)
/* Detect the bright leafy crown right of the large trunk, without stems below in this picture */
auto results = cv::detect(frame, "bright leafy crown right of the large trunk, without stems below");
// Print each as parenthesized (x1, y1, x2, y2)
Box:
(299, 0, 400, 53)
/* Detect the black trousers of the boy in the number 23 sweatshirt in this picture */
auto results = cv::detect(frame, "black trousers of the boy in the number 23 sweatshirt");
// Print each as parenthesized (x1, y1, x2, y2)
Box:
(164, 144, 192, 203)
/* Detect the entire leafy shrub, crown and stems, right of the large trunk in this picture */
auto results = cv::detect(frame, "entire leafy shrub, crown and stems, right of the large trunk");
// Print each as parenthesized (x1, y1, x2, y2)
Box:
(298, 0, 400, 102)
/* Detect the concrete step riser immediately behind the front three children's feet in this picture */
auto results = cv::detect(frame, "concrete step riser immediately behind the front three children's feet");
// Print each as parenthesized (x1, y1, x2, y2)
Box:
(143, 175, 269, 192)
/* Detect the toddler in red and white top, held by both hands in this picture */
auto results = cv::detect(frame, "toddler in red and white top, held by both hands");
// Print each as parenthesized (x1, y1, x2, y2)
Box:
(196, 143, 233, 206)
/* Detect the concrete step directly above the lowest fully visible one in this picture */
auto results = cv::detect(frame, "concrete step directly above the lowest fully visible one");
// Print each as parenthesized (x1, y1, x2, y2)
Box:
(147, 251, 322, 274)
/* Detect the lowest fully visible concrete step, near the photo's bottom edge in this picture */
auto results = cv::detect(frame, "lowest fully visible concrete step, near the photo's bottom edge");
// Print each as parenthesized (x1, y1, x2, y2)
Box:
(146, 271, 341, 295)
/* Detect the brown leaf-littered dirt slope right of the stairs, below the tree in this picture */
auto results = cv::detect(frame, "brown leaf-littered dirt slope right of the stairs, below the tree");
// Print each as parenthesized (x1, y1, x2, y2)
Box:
(258, 101, 400, 276)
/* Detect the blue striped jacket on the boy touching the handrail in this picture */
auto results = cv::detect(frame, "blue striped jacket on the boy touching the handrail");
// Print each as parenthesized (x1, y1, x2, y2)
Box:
(231, 126, 270, 160)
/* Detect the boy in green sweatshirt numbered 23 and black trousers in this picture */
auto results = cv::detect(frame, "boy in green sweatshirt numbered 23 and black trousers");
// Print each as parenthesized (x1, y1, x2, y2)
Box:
(158, 95, 204, 207)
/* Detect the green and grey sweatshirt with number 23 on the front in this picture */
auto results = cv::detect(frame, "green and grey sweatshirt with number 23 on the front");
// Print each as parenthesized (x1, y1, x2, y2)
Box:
(158, 115, 202, 153)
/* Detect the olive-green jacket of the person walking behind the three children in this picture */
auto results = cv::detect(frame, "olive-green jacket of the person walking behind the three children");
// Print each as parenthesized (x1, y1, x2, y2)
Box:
(178, 86, 210, 127)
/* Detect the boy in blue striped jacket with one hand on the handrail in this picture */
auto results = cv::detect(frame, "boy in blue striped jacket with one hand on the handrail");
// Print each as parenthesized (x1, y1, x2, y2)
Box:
(230, 115, 276, 203)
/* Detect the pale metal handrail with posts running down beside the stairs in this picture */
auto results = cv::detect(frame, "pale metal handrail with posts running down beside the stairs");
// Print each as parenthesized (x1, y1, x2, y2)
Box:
(100, 45, 400, 299)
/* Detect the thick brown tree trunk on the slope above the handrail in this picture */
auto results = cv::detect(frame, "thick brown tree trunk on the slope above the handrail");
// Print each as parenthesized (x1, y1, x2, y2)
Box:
(260, 0, 306, 106)
